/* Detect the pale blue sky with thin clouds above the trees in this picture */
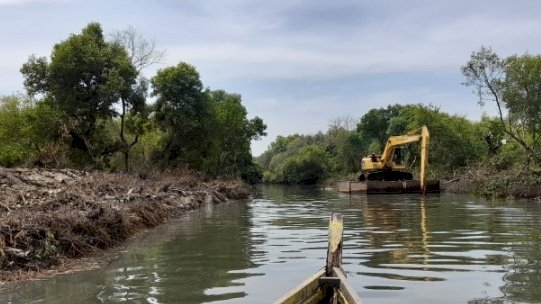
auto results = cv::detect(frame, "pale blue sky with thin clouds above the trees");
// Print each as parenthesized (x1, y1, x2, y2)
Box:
(0, 0, 541, 156)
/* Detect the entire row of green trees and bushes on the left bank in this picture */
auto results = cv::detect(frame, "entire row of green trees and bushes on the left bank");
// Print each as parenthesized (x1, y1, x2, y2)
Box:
(0, 23, 266, 181)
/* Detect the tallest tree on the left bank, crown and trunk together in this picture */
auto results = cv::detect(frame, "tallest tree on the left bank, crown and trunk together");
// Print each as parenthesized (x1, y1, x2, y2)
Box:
(21, 23, 137, 167)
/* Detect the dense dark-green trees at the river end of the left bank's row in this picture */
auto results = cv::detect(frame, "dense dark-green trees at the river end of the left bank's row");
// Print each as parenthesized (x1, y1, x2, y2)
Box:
(151, 63, 266, 180)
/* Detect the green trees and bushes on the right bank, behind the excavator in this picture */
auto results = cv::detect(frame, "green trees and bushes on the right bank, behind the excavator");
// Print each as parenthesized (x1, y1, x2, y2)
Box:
(257, 47, 541, 197)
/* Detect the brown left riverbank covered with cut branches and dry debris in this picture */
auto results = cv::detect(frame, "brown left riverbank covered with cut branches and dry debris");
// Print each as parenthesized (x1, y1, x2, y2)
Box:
(0, 168, 250, 281)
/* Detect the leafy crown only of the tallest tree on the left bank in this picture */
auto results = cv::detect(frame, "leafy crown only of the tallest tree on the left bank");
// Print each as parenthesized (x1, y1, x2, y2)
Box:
(21, 23, 136, 121)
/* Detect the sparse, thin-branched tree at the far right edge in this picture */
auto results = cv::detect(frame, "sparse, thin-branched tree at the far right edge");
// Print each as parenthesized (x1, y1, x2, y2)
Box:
(461, 47, 541, 165)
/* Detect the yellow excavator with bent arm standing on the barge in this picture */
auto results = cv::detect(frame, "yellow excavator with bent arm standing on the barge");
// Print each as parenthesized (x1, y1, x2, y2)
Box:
(358, 126, 430, 193)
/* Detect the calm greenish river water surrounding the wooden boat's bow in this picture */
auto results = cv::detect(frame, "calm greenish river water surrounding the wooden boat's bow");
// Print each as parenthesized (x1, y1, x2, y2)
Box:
(0, 186, 541, 304)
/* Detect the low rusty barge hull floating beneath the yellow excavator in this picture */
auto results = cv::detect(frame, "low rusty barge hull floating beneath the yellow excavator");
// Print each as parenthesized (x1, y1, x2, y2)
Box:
(336, 180, 440, 194)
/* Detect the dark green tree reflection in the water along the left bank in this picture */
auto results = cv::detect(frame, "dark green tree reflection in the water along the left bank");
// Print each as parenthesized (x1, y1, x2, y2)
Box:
(0, 203, 258, 303)
